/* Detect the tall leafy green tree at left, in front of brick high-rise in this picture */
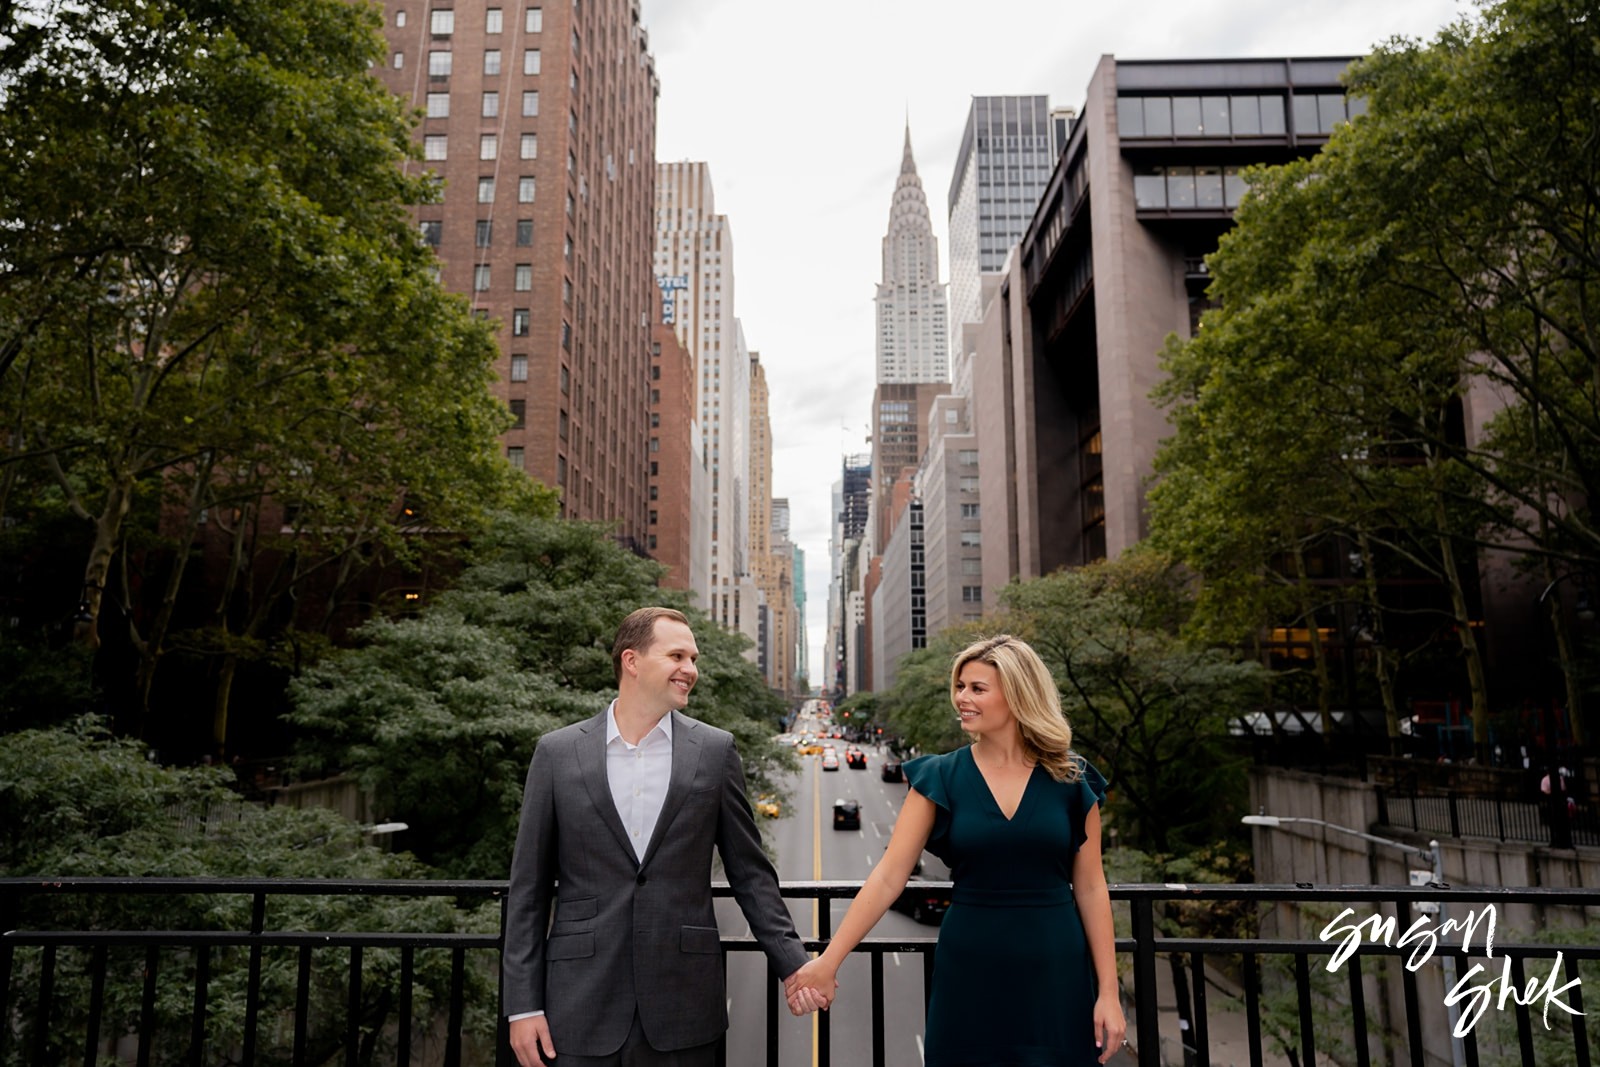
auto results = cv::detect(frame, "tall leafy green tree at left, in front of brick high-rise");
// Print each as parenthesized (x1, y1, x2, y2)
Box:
(0, 0, 544, 750)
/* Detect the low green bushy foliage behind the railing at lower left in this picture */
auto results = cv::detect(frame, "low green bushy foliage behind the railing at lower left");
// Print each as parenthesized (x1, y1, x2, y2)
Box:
(0, 720, 499, 1064)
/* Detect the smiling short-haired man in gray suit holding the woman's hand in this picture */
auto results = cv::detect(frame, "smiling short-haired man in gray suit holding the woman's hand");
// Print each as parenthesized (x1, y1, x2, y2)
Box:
(502, 608, 822, 1067)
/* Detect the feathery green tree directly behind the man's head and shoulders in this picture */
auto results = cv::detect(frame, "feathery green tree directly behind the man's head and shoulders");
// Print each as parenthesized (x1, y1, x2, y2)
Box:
(291, 515, 795, 878)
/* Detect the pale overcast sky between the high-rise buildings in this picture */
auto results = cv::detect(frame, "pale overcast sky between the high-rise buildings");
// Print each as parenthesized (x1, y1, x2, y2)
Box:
(643, 0, 1475, 685)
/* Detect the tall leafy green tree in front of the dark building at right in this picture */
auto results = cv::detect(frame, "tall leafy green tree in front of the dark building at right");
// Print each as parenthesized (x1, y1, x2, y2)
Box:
(1150, 0, 1600, 744)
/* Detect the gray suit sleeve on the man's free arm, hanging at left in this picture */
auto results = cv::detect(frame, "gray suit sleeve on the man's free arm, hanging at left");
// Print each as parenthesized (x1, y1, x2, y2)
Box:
(501, 742, 557, 1016)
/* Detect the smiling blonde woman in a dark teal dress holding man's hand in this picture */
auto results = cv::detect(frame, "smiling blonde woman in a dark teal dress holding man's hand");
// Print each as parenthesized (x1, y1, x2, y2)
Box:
(790, 635, 1128, 1067)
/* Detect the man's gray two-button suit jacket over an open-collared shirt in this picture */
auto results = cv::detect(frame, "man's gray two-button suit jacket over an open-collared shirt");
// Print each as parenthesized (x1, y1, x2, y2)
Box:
(501, 712, 808, 1056)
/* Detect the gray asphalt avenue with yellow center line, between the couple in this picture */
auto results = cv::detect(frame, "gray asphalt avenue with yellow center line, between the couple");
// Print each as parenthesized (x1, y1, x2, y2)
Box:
(717, 742, 949, 1067)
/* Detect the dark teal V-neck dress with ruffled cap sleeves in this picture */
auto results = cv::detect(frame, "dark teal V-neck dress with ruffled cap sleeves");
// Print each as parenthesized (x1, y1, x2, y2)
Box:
(906, 747, 1106, 1067)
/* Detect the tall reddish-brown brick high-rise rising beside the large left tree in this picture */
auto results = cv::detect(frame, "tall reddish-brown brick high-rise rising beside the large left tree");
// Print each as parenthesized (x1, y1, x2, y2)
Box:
(381, 0, 658, 549)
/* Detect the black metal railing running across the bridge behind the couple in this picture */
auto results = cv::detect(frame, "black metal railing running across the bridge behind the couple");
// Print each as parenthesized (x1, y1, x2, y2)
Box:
(0, 878, 1600, 1067)
